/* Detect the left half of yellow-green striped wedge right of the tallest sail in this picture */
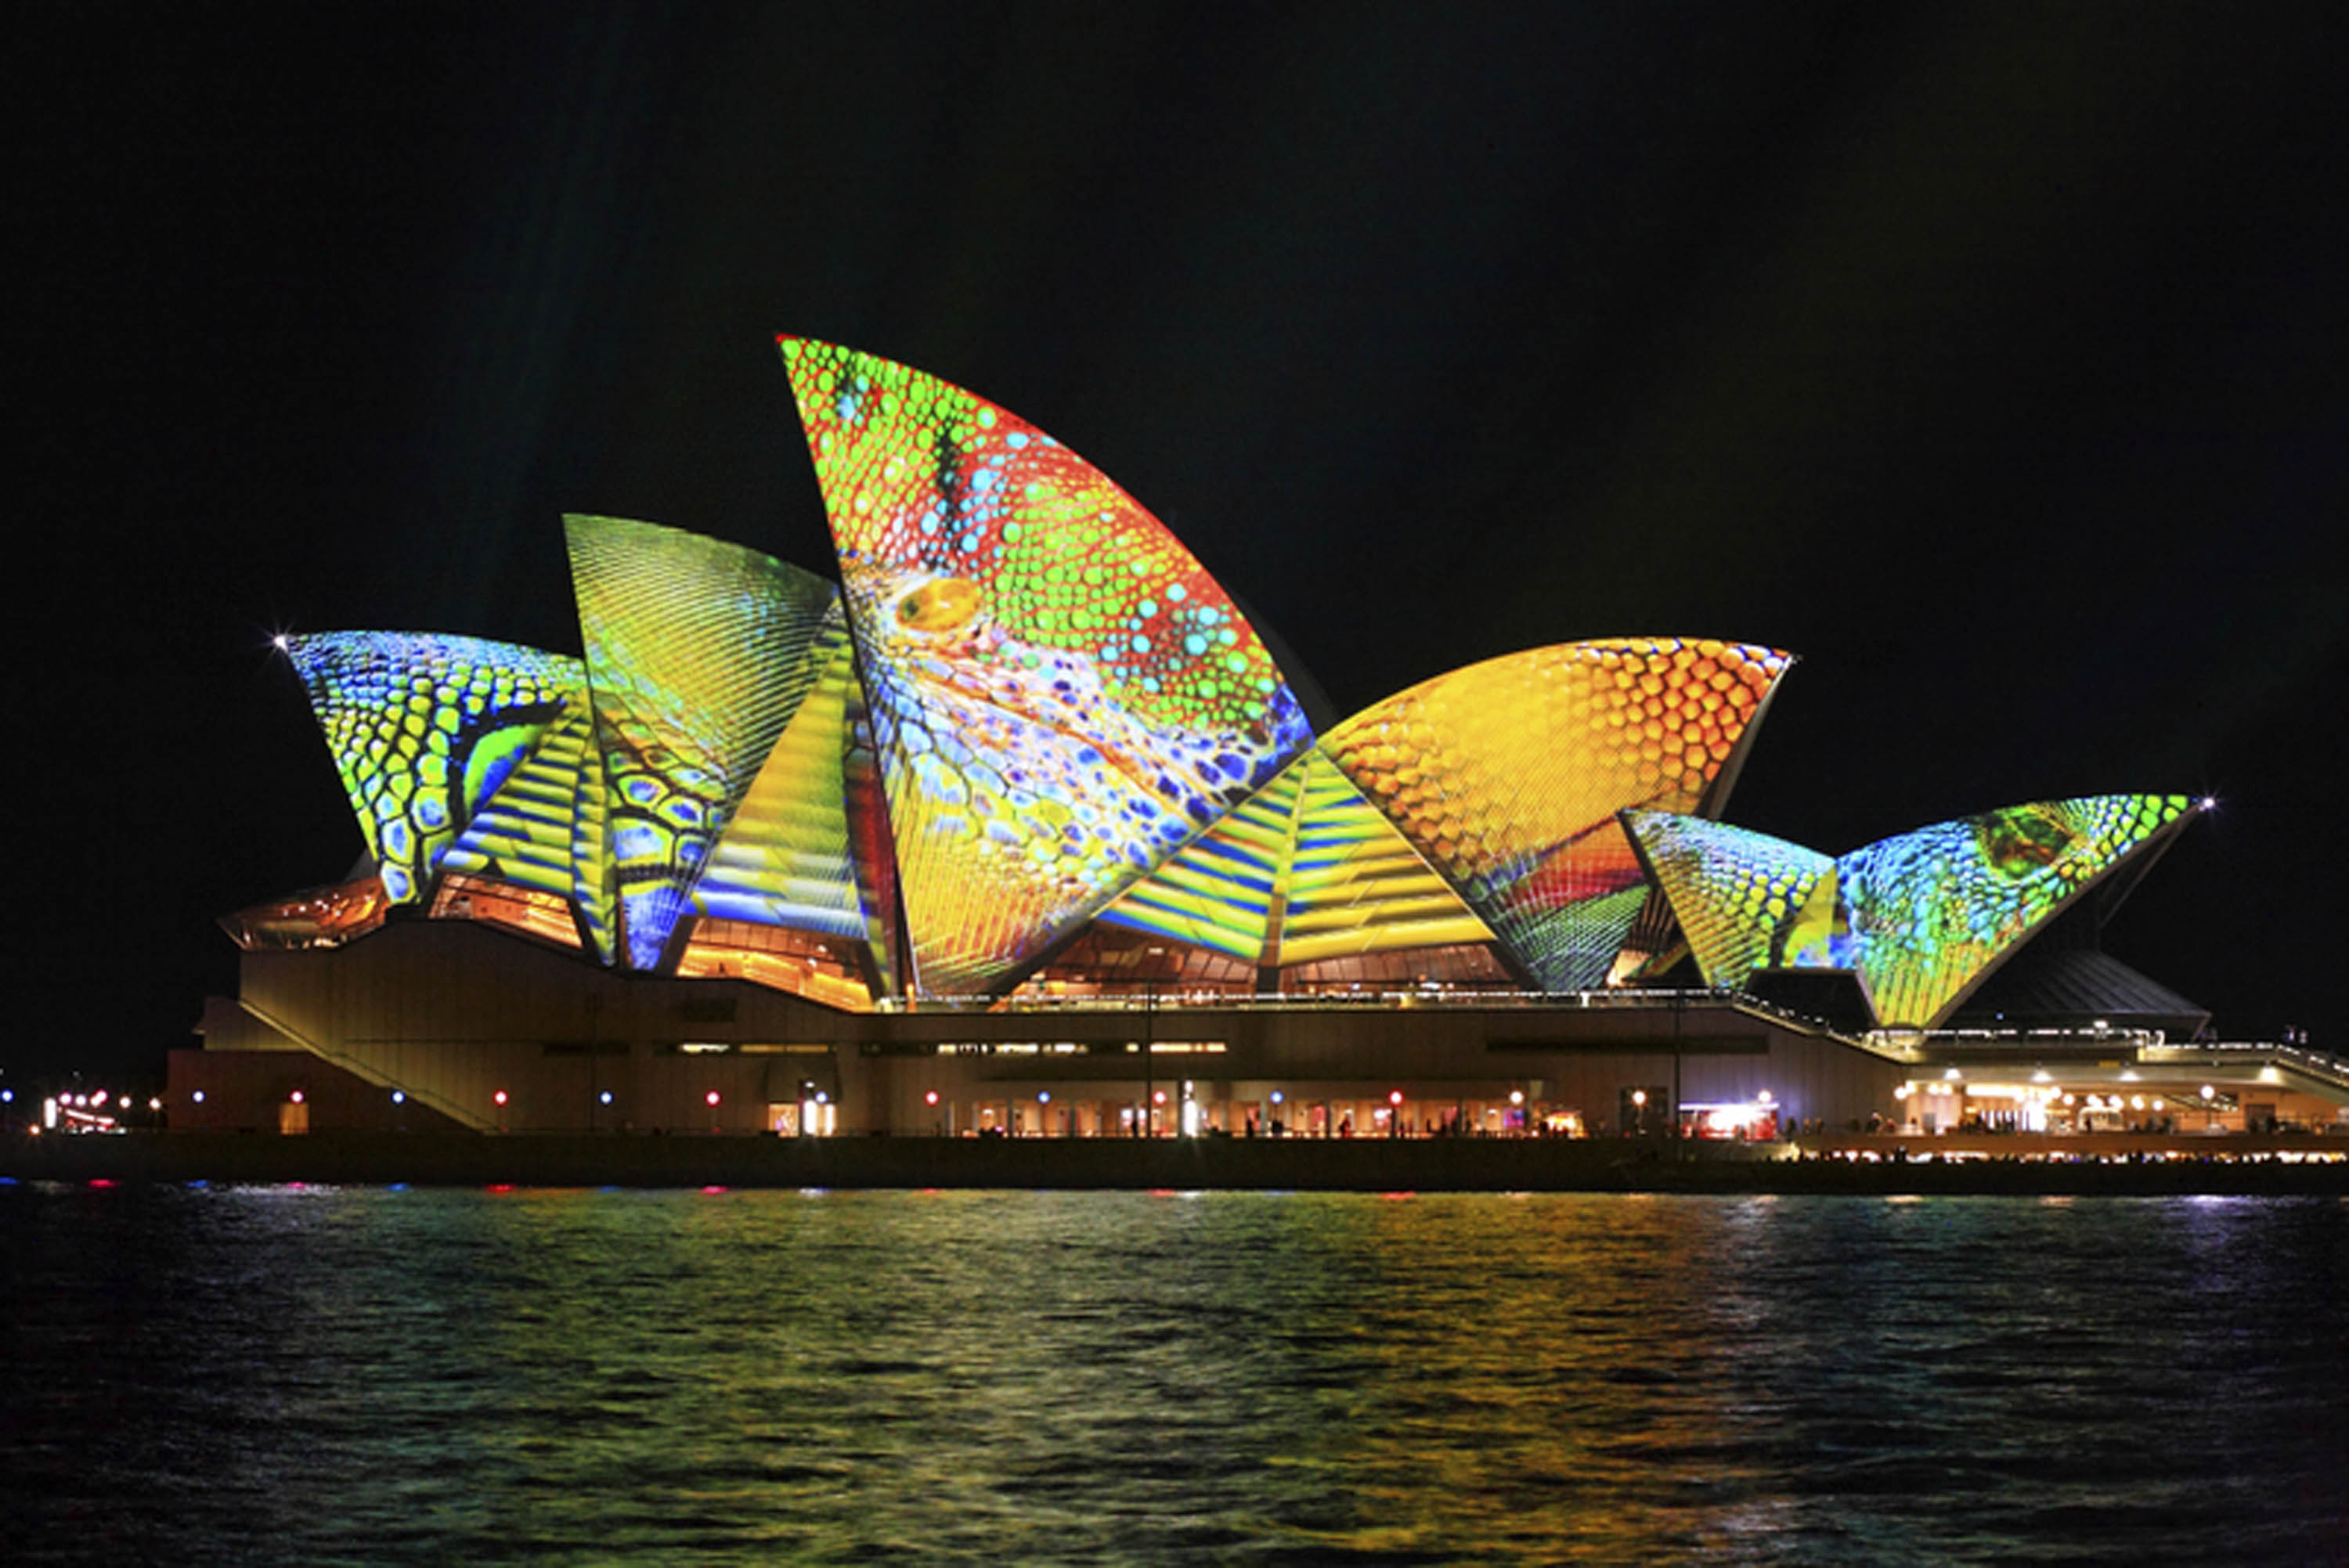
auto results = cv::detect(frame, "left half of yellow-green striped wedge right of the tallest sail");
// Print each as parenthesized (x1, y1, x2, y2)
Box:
(1099, 752, 1313, 964)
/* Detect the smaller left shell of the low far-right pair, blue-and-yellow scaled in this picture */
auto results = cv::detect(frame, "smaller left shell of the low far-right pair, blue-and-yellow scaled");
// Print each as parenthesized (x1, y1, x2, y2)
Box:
(1623, 812, 1835, 990)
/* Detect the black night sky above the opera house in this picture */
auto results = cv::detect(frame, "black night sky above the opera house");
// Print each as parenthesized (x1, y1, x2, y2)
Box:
(23, 2, 2349, 1077)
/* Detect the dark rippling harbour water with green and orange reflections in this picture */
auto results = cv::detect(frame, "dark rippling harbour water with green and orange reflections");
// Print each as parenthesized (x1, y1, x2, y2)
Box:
(0, 1188, 2349, 1563)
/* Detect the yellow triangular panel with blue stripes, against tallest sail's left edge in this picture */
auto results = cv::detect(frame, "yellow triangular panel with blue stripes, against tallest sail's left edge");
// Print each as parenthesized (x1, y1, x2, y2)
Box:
(693, 608, 867, 941)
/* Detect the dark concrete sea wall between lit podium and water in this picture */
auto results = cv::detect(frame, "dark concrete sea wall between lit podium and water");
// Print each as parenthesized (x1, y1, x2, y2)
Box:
(0, 1134, 2349, 1197)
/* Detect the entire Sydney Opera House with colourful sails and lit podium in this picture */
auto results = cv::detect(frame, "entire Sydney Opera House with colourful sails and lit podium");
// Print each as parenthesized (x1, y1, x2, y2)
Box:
(169, 338, 2340, 1136)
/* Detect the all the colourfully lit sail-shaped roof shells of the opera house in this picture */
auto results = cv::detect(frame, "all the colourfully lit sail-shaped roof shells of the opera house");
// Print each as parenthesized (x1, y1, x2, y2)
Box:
(266, 338, 2201, 1009)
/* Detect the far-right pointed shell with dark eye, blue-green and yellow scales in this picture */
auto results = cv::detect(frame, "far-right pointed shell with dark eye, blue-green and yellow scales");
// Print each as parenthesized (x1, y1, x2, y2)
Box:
(1825, 795, 2196, 1028)
